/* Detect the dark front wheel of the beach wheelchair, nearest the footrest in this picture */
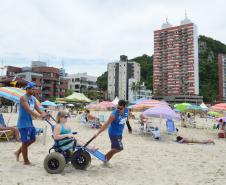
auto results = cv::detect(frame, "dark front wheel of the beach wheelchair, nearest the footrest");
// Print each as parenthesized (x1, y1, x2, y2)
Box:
(71, 150, 91, 170)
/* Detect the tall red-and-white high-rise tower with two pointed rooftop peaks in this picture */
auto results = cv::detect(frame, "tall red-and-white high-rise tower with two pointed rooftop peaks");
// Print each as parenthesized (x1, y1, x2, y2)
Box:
(153, 16, 199, 96)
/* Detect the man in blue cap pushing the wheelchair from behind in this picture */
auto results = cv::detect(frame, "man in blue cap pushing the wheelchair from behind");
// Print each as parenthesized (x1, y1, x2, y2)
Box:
(15, 82, 46, 165)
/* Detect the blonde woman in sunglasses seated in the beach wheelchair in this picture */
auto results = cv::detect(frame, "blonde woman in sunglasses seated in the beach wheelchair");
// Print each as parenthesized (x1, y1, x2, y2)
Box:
(53, 111, 97, 151)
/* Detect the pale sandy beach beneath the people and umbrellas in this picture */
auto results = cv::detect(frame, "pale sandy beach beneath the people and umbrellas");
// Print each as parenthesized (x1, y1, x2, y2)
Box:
(0, 112, 226, 185)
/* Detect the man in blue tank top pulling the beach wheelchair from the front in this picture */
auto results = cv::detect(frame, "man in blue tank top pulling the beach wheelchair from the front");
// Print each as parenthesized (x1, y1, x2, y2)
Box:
(95, 100, 132, 165)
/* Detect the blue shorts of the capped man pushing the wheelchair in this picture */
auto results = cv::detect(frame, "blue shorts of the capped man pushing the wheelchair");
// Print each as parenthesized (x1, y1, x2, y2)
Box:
(19, 127, 36, 143)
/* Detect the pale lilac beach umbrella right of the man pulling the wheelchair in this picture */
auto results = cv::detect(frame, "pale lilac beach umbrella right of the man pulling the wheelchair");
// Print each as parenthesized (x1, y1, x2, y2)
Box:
(142, 106, 180, 120)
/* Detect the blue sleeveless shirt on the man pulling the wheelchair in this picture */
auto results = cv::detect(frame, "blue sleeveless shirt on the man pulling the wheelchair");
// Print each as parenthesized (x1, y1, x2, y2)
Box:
(108, 108, 129, 136)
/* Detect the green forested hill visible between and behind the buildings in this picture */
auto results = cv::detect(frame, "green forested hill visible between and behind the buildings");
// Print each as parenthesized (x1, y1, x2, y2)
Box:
(97, 35, 226, 103)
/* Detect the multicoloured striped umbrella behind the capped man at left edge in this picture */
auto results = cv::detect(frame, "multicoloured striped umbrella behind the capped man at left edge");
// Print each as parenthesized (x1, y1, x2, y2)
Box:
(0, 87, 44, 109)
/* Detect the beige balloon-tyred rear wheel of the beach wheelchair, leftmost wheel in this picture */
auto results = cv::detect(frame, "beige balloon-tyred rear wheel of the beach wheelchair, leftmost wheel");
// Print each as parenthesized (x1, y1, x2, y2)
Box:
(44, 152, 66, 174)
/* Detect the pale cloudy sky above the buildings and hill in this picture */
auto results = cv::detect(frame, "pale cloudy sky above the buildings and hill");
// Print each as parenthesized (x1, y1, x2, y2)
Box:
(0, 0, 226, 76)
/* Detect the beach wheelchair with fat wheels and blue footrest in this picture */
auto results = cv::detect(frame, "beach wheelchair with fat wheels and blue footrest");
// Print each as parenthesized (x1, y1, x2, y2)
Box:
(44, 116, 106, 174)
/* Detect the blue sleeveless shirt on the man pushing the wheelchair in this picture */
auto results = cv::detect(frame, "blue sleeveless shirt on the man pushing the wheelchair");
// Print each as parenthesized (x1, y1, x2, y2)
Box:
(17, 94, 36, 128)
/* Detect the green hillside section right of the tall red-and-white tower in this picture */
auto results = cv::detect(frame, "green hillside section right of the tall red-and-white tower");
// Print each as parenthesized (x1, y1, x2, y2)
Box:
(199, 35, 226, 103)
